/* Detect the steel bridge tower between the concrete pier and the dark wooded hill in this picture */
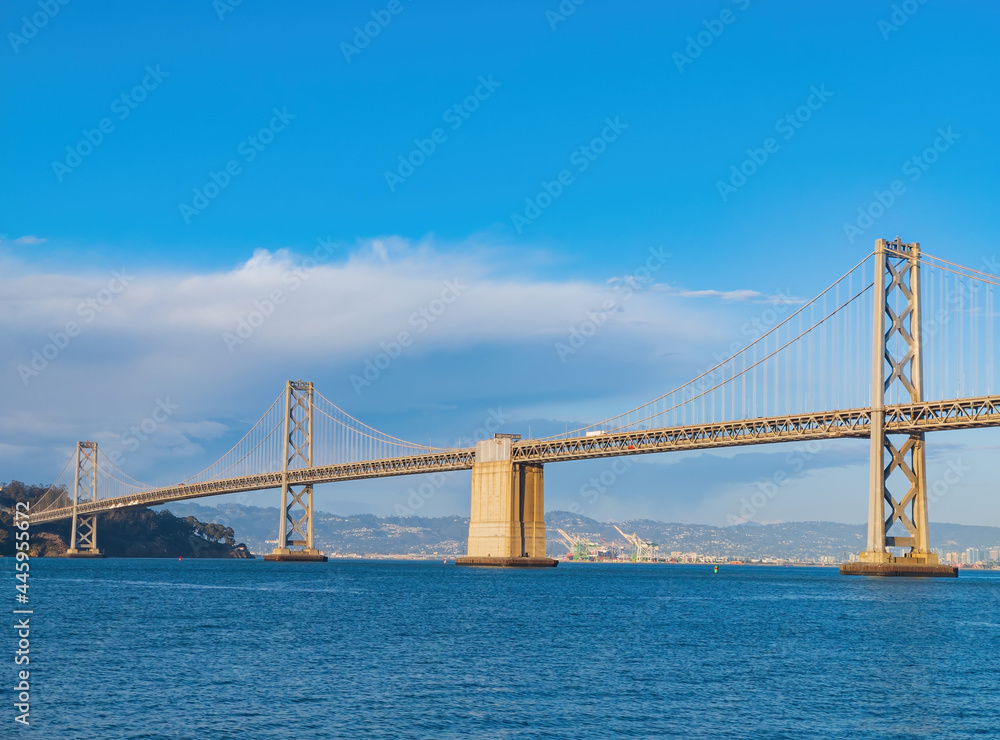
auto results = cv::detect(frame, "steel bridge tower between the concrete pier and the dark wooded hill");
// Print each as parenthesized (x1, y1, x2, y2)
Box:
(264, 380, 327, 563)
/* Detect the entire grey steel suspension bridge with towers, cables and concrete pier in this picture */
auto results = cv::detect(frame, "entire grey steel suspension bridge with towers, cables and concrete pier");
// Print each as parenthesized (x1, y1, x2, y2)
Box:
(30, 237, 1000, 575)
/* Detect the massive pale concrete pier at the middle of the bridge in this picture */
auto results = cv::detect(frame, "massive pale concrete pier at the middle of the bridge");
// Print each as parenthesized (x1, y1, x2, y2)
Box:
(455, 436, 558, 568)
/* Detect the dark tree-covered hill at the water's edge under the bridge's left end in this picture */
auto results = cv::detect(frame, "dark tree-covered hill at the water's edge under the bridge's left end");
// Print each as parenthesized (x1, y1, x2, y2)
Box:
(0, 481, 254, 558)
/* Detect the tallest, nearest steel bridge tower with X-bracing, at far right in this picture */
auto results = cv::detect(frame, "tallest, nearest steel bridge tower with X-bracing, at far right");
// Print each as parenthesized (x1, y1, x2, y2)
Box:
(840, 237, 958, 577)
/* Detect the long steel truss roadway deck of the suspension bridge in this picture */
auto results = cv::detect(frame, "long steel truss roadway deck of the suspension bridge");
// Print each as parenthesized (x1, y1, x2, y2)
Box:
(30, 396, 1000, 524)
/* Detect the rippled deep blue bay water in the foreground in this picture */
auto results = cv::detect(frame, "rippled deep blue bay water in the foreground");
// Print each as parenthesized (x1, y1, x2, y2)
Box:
(9, 559, 1000, 740)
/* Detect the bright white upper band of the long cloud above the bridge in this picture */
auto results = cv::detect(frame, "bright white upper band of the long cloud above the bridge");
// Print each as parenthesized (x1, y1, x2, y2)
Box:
(0, 240, 721, 356)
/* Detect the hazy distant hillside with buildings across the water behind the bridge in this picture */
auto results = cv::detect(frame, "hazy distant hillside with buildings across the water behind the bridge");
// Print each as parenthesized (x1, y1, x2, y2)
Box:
(158, 501, 1000, 560)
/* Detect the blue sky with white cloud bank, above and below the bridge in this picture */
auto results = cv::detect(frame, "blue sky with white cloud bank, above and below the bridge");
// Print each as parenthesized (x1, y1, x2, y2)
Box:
(0, 0, 1000, 524)
